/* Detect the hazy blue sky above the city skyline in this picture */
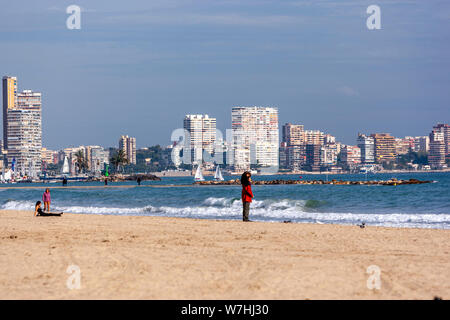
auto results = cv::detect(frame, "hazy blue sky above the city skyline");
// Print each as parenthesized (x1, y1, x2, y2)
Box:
(0, 0, 450, 149)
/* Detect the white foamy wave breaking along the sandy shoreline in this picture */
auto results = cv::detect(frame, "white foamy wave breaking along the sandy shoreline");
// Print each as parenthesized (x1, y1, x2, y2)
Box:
(0, 197, 450, 229)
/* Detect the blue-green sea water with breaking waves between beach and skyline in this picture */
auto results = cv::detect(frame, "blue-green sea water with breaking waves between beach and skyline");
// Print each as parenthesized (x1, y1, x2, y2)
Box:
(0, 173, 450, 229)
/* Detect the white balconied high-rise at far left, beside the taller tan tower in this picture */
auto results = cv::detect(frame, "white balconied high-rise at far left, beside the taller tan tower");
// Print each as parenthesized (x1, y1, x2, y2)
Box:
(4, 88, 42, 176)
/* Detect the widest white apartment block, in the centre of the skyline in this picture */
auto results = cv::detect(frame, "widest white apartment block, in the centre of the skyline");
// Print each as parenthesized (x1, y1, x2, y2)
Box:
(231, 107, 279, 171)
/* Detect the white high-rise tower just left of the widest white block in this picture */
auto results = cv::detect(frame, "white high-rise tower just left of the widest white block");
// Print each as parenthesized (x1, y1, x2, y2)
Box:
(183, 114, 216, 164)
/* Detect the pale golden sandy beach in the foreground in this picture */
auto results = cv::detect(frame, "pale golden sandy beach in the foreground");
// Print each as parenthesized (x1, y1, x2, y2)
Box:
(0, 211, 450, 299)
